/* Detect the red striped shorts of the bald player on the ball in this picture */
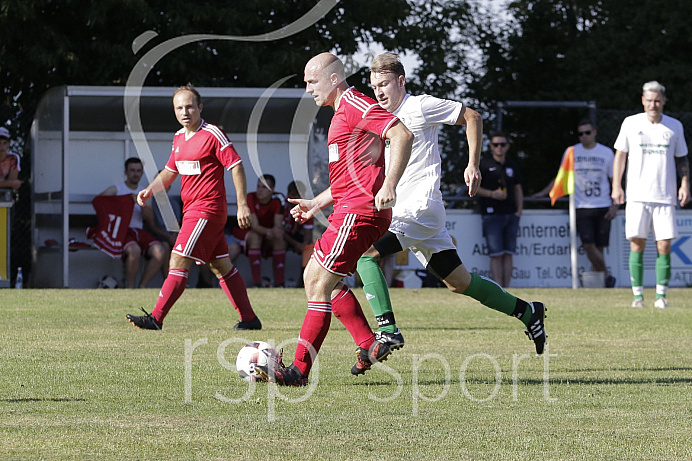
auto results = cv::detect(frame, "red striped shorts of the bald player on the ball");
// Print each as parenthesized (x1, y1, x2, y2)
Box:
(312, 213, 391, 277)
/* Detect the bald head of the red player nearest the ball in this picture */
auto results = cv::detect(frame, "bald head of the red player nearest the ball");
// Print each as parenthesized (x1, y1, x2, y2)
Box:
(304, 53, 348, 109)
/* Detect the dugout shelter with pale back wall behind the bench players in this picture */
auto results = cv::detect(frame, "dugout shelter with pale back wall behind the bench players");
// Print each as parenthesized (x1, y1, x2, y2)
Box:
(31, 86, 329, 288)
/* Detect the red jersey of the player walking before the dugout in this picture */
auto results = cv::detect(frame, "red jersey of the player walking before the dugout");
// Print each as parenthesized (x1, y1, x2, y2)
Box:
(166, 120, 241, 222)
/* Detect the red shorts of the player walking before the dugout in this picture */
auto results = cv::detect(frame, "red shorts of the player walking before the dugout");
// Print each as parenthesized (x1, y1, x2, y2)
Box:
(171, 215, 228, 264)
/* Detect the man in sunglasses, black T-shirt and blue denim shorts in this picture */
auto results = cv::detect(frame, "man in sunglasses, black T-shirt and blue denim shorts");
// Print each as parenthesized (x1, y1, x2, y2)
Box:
(478, 133, 524, 287)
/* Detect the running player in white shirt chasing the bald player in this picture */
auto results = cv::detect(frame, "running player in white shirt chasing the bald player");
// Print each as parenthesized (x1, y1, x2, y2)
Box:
(358, 53, 546, 354)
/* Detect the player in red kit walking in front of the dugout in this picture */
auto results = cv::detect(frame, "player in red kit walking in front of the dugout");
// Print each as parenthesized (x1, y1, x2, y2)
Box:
(127, 83, 262, 330)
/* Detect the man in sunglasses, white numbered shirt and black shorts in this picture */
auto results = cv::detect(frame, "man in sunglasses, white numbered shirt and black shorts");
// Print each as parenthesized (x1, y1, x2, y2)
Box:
(531, 119, 619, 288)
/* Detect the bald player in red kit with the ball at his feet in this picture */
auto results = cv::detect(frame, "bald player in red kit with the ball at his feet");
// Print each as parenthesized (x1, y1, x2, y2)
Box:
(260, 53, 413, 386)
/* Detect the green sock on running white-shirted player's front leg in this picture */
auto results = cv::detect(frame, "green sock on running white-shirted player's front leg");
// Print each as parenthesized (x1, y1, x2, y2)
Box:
(357, 256, 397, 333)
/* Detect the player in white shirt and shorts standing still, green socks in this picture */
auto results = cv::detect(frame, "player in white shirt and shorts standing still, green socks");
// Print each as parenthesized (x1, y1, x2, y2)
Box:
(612, 81, 690, 309)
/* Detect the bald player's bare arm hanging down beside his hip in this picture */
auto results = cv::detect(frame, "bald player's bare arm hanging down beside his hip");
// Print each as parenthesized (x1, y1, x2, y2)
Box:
(375, 121, 413, 210)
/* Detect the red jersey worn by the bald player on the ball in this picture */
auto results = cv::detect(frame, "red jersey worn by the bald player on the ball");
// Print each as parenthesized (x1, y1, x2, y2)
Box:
(328, 88, 398, 217)
